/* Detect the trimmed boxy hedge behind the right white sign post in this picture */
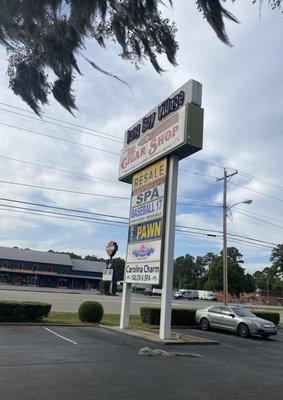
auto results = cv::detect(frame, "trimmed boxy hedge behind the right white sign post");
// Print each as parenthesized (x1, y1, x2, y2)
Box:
(140, 307, 199, 326)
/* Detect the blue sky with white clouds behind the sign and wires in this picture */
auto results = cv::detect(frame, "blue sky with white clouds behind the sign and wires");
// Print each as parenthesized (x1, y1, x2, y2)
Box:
(0, 0, 283, 272)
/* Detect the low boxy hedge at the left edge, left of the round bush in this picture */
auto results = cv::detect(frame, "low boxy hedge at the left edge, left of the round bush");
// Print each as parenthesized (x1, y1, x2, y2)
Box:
(0, 301, 51, 322)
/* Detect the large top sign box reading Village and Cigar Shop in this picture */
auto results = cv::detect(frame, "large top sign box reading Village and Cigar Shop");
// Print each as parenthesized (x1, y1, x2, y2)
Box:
(119, 80, 203, 183)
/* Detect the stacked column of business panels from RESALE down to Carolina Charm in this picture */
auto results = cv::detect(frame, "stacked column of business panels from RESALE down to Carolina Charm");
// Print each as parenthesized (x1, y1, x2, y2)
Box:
(124, 159, 167, 284)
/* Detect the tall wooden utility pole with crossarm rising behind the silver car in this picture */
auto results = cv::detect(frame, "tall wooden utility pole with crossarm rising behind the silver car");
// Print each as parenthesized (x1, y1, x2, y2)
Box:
(217, 168, 238, 306)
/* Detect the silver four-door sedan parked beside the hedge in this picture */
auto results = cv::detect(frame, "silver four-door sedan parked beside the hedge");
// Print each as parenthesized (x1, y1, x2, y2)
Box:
(195, 306, 277, 337)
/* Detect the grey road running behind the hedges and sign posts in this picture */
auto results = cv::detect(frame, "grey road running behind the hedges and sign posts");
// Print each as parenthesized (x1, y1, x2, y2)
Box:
(0, 286, 283, 322)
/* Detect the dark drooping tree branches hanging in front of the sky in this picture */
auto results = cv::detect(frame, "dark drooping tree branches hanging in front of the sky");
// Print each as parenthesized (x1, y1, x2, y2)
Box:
(0, 0, 283, 114)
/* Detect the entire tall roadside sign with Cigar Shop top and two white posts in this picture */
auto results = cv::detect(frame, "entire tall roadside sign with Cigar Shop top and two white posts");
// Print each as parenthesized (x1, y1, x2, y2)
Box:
(119, 80, 203, 339)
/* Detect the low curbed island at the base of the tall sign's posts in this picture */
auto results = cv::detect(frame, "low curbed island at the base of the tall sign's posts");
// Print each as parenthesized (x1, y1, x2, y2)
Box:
(100, 325, 219, 346)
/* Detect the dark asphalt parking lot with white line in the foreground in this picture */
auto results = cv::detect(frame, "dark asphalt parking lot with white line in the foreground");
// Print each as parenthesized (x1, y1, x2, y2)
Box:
(0, 325, 283, 400)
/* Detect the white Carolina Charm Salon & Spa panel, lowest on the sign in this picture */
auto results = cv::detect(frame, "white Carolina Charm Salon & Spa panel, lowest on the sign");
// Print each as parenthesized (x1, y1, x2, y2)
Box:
(124, 262, 160, 285)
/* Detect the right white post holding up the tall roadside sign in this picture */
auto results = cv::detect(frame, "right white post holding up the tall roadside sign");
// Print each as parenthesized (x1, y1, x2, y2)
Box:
(159, 156, 179, 339)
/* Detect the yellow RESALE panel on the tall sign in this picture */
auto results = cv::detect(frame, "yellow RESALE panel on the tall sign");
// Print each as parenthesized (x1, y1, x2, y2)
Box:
(132, 158, 167, 191)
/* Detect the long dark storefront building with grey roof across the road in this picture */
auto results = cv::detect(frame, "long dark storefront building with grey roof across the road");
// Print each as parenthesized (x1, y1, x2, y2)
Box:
(0, 247, 105, 289)
